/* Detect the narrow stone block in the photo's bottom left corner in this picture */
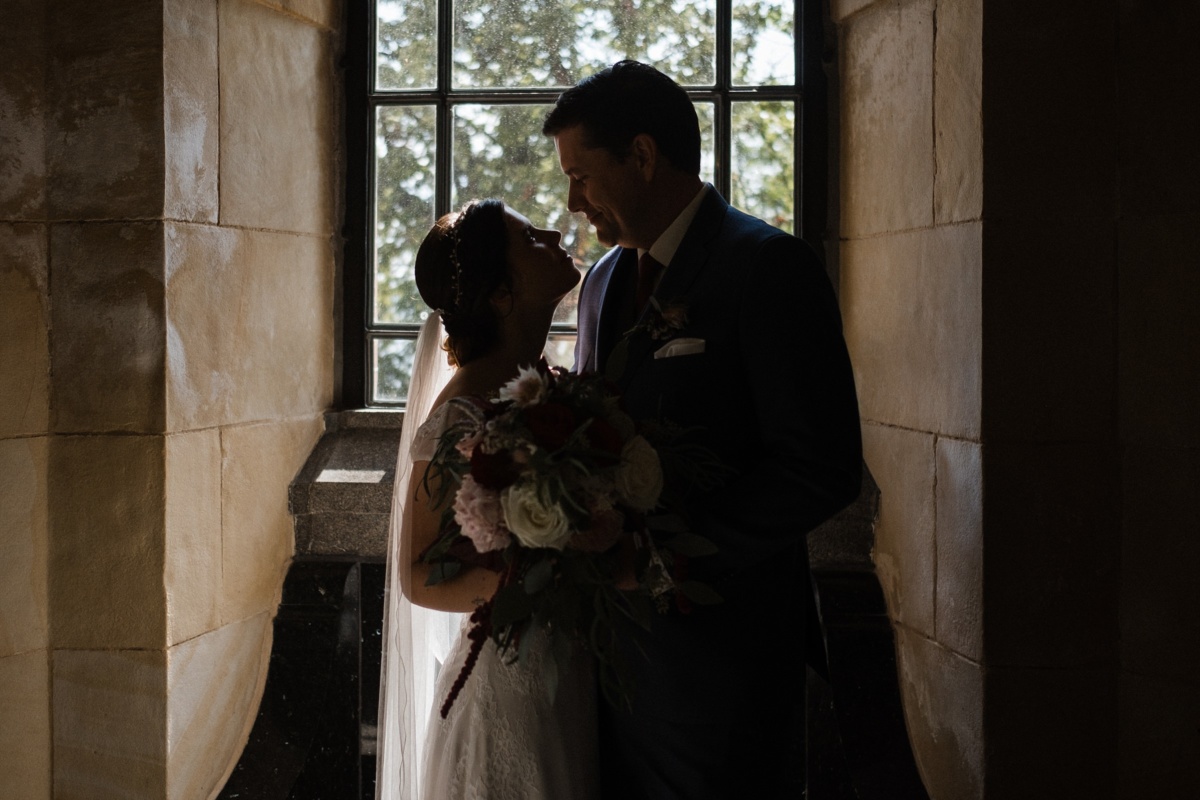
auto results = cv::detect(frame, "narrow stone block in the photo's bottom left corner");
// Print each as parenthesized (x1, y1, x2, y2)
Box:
(0, 649, 52, 800)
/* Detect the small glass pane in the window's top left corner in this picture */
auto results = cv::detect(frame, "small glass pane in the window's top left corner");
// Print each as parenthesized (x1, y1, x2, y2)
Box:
(376, 0, 438, 91)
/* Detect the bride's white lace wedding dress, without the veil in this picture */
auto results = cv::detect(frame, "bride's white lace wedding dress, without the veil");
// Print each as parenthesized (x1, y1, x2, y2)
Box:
(412, 403, 599, 800)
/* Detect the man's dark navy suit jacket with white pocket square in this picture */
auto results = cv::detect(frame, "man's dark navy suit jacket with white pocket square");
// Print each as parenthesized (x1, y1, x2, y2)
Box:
(575, 188, 862, 786)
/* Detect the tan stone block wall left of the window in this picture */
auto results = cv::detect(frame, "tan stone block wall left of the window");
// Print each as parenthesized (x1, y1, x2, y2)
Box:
(0, 0, 340, 800)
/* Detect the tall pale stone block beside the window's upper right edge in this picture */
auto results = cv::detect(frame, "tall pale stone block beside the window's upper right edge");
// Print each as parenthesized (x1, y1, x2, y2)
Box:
(840, 0, 935, 237)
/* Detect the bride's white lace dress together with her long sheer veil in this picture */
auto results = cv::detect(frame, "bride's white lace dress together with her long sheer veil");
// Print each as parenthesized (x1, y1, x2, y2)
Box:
(376, 313, 600, 800)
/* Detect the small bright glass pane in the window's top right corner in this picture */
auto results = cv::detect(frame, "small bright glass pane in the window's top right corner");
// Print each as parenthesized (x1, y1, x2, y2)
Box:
(730, 0, 796, 86)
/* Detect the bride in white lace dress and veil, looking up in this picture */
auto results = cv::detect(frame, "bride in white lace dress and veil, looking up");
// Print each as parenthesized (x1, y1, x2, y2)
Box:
(377, 200, 599, 800)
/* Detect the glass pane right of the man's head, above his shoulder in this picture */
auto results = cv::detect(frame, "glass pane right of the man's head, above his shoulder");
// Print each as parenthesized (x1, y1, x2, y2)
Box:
(731, 101, 796, 231)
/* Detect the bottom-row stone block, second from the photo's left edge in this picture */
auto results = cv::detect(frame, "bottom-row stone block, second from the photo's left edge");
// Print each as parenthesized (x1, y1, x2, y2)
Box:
(54, 650, 167, 800)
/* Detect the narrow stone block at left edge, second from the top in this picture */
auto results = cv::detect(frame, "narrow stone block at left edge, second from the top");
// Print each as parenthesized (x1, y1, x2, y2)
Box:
(0, 221, 50, 435)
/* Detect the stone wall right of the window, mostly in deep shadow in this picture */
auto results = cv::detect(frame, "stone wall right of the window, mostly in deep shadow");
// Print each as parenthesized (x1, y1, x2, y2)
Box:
(833, 0, 1200, 800)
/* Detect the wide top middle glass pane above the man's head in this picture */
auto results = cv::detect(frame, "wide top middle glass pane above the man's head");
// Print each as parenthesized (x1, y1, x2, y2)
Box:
(452, 0, 716, 89)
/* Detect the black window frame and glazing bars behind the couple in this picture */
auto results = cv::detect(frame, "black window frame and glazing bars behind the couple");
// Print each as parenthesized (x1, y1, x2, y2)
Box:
(335, 0, 828, 410)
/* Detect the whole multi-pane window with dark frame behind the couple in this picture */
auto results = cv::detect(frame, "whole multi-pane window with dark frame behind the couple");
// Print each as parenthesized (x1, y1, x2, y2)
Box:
(342, 0, 823, 405)
